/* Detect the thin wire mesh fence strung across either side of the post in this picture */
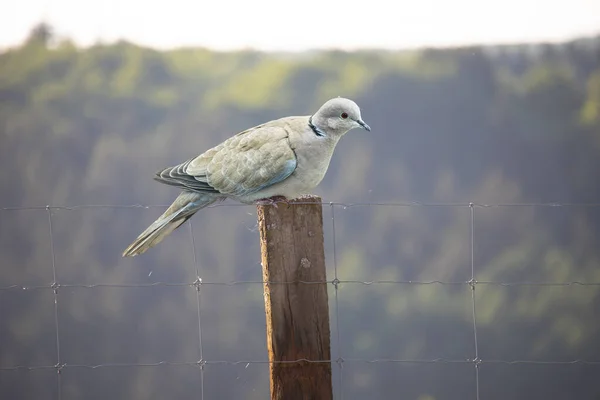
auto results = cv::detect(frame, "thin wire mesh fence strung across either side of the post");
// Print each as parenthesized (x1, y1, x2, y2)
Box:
(0, 202, 600, 400)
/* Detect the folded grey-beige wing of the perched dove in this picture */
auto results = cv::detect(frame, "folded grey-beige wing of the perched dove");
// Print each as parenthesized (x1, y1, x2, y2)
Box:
(155, 120, 297, 196)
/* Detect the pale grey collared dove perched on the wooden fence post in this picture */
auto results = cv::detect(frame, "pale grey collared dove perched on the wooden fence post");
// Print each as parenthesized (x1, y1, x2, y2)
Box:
(122, 97, 371, 257)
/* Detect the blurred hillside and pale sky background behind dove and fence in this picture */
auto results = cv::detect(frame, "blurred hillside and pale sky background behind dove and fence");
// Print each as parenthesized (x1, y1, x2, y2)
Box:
(0, 0, 600, 400)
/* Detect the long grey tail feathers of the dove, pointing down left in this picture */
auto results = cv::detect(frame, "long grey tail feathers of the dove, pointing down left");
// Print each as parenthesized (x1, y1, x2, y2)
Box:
(123, 191, 220, 257)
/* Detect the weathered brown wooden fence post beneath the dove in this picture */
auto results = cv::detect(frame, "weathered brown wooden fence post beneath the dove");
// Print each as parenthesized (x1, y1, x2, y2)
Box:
(258, 196, 333, 400)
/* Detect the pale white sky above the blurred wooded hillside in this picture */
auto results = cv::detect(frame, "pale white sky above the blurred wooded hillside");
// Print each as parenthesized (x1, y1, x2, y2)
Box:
(0, 0, 600, 51)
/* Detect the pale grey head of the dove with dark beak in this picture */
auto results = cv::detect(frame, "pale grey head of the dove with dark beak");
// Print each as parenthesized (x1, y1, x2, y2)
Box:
(312, 97, 371, 135)
